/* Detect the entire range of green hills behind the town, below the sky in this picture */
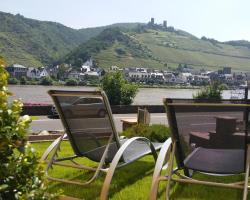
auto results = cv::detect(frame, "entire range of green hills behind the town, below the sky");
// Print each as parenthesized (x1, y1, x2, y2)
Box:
(0, 12, 250, 71)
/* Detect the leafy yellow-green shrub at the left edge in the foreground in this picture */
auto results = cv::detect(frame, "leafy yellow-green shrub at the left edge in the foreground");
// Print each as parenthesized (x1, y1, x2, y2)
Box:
(0, 64, 54, 200)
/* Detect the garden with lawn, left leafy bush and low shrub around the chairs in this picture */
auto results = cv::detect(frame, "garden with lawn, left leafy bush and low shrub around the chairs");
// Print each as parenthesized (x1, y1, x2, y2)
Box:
(0, 60, 249, 200)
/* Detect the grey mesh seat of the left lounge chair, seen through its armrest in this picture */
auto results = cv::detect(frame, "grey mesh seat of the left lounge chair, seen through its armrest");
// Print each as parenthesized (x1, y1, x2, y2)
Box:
(84, 139, 162, 163)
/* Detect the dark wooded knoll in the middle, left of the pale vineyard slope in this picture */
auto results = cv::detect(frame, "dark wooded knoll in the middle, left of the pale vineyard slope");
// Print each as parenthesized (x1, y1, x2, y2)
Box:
(63, 28, 152, 66)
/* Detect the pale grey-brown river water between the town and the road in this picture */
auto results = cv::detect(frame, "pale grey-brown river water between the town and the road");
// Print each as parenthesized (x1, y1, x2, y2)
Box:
(9, 85, 240, 105)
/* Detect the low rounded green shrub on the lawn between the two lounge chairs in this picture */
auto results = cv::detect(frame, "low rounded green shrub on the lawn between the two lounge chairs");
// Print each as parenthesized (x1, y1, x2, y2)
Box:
(122, 124, 170, 142)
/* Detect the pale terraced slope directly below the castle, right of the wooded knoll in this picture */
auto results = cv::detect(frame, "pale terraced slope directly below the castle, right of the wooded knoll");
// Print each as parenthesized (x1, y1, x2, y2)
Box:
(137, 31, 250, 70)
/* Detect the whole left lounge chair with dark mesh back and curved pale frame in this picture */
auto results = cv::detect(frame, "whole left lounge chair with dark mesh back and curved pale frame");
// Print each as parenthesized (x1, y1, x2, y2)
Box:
(42, 90, 162, 199)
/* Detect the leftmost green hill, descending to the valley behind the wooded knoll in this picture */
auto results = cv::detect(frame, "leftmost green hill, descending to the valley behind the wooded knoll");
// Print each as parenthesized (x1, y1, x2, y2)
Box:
(0, 12, 140, 66)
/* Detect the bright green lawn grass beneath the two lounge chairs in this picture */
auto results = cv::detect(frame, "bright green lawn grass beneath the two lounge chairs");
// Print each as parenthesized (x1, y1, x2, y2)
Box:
(32, 142, 250, 200)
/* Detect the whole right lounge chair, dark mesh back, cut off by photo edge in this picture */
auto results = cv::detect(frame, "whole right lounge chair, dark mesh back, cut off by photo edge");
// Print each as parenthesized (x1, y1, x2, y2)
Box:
(150, 99, 250, 200)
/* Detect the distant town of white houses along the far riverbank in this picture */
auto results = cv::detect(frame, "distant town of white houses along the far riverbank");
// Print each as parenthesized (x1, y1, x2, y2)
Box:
(6, 59, 250, 88)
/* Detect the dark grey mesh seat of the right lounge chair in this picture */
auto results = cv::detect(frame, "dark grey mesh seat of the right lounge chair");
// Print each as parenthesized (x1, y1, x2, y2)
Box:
(184, 147, 245, 174)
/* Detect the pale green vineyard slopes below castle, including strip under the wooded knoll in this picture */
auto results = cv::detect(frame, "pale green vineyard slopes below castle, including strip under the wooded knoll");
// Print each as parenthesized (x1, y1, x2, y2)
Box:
(94, 30, 250, 71)
